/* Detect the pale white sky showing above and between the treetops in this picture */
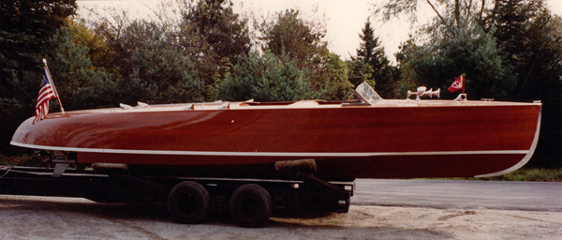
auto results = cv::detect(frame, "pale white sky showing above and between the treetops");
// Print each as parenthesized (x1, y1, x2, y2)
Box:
(78, 0, 562, 61)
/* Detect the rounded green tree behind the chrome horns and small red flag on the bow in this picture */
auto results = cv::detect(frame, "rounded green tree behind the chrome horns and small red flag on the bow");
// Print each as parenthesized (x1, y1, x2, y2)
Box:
(394, 17, 515, 100)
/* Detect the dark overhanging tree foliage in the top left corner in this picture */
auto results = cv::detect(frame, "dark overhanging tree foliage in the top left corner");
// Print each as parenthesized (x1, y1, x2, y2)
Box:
(0, 0, 77, 76)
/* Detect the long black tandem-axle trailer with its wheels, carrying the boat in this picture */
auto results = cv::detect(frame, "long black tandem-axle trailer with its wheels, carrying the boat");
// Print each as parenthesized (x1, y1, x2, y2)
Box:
(0, 159, 355, 227)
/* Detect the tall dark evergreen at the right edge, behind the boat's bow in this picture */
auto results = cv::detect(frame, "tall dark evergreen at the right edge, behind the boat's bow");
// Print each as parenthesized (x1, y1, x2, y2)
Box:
(491, 1, 562, 167)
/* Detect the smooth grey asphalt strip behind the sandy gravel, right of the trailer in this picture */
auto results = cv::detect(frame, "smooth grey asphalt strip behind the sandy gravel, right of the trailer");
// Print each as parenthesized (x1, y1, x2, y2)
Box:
(351, 179, 562, 212)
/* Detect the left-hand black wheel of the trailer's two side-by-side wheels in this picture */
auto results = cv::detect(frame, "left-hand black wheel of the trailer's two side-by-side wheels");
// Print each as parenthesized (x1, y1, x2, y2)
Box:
(167, 181, 211, 224)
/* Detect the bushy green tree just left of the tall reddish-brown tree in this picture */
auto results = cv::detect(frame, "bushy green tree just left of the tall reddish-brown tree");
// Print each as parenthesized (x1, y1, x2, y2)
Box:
(110, 21, 205, 104)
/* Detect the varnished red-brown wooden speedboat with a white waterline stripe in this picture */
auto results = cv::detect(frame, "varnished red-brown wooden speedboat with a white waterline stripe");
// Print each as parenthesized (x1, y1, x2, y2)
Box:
(11, 85, 541, 179)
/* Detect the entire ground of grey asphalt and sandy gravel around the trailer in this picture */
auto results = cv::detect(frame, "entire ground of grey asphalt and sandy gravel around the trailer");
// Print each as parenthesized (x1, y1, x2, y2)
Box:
(0, 180, 562, 240)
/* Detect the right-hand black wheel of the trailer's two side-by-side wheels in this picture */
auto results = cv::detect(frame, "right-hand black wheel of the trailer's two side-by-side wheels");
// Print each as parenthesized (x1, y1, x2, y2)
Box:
(230, 184, 273, 228)
